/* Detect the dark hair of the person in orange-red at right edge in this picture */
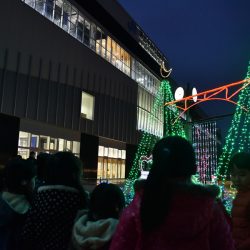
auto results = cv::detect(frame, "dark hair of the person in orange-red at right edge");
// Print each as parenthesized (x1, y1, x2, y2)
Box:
(229, 152, 250, 172)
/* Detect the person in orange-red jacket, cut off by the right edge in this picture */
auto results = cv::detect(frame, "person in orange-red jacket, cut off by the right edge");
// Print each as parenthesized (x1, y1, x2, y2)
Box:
(229, 152, 250, 250)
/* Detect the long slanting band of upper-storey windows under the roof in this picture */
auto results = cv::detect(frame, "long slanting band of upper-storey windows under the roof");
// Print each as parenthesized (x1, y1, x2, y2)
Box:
(21, 0, 159, 94)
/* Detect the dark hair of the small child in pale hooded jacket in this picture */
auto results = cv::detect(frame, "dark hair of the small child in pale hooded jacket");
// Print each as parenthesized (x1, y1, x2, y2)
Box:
(89, 183, 125, 220)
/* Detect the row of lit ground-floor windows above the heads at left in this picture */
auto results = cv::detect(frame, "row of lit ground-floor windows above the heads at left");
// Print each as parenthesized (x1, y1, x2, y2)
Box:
(18, 131, 80, 159)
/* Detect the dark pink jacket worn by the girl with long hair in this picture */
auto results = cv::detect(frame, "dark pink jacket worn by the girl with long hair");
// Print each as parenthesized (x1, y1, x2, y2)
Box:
(110, 185, 234, 250)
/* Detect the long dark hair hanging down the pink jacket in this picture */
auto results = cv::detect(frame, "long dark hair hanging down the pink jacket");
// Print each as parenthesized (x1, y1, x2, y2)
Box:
(141, 136, 196, 231)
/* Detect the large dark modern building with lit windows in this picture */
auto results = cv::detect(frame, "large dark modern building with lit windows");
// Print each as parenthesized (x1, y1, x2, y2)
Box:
(0, 0, 200, 179)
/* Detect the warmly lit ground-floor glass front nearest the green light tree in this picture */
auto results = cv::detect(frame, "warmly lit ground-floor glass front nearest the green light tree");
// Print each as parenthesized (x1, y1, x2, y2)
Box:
(97, 146, 126, 179)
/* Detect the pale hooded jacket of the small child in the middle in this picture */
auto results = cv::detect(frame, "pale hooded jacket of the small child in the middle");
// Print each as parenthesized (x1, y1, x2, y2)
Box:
(72, 210, 118, 250)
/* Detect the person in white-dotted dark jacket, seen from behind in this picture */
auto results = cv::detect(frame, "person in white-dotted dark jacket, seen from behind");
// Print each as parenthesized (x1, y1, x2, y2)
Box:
(21, 152, 87, 250)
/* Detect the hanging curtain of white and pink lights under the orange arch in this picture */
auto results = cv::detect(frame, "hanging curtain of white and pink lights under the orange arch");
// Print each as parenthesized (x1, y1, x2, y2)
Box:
(192, 121, 217, 183)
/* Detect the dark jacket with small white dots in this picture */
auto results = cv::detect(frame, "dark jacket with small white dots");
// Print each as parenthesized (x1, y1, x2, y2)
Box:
(22, 185, 82, 250)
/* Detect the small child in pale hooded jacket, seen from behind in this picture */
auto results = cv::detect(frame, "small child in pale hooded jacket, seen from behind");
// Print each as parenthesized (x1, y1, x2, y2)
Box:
(71, 183, 125, 250)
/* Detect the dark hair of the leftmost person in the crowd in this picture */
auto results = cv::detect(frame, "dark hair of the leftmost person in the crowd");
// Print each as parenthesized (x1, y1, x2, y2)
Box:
(3, 159, 35, 194)
